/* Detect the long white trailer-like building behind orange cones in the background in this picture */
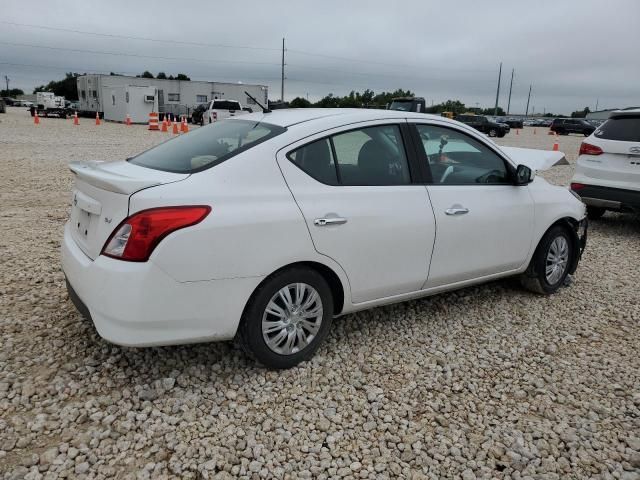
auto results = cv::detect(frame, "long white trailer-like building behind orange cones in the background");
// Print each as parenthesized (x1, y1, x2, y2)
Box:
(77, 74, 269, 123)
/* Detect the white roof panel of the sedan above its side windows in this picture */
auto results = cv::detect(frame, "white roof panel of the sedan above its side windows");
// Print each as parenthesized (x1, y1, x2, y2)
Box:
(235, 108, 451, 127)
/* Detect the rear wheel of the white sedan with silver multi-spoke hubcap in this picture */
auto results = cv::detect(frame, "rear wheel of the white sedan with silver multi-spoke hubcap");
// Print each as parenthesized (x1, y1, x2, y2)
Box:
(236, 267, 333, 369)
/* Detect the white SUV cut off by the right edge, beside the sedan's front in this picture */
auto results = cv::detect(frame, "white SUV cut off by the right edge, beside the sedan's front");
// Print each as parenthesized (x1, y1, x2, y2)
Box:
(571, 109, 640, 219)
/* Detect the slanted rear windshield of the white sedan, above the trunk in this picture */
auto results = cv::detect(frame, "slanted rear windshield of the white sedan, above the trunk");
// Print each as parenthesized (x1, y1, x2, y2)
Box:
(129, 120, 286, 173)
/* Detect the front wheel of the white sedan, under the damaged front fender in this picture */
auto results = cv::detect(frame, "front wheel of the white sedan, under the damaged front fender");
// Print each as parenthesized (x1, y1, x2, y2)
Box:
(520, 225, 576, 295)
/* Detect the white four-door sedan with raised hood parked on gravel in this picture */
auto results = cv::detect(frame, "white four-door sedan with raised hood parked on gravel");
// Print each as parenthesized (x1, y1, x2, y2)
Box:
(62, 109, 586, 368)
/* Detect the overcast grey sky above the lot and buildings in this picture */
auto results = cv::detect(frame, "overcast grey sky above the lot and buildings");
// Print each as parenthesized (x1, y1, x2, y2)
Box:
(0, 0, 640, 113)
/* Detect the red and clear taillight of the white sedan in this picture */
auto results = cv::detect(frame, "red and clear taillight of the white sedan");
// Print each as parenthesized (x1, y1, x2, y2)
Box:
(102, 205, 211, 262)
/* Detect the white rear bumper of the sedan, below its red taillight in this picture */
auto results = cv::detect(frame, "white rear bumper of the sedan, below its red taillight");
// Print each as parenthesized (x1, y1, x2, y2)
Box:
(62, 225, 262, 347)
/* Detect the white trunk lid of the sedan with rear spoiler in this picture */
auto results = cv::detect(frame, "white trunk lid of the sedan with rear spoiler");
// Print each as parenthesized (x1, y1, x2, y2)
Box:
(69, 161, 189, 259)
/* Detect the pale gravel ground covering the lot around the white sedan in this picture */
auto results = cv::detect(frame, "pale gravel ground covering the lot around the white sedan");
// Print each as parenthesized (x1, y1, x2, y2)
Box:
(0, 108, 640, 480)
